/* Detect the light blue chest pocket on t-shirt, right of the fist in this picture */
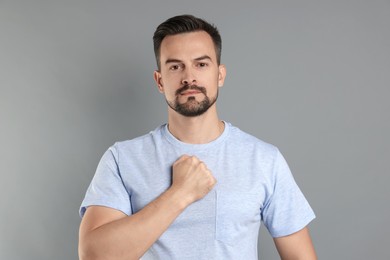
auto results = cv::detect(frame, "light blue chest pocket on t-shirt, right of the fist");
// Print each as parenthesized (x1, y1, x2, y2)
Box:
(216, 191, 260, 245)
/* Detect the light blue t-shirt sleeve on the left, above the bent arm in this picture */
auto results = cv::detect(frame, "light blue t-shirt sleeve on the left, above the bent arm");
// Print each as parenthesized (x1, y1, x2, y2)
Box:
(79, 145, 132, 217)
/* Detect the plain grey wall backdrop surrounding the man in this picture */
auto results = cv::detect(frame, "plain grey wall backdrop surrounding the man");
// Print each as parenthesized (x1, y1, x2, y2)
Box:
(0, 0, 390, 260)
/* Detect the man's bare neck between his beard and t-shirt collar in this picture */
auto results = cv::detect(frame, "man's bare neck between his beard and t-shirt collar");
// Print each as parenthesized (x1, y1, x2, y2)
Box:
(168, 105, 225, 144)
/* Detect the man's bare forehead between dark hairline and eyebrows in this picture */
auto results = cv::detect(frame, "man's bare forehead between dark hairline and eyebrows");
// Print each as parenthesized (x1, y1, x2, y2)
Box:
(160, 31, 216, 63)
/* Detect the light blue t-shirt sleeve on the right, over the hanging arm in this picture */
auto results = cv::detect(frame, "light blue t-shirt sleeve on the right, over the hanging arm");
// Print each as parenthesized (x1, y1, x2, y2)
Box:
(261, 148, 315, 237)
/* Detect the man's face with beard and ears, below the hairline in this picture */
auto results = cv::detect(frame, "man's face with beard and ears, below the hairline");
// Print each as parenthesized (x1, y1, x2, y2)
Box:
(154, 31, 226, 116)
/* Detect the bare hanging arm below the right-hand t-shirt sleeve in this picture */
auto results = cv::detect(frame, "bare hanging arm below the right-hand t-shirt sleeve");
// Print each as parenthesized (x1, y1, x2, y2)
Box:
(274, 227, 317, 260)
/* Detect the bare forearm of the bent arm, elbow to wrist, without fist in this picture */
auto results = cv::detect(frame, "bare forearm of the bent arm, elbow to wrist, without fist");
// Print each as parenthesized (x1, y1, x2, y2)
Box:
(80, 189, 187, 260)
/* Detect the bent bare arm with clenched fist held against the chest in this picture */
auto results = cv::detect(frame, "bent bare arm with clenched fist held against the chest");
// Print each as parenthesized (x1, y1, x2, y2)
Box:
(79, 156, 216, 260)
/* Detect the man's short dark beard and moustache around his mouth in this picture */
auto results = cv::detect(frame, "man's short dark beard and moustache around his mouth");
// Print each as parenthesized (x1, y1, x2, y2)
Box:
(166, 85, 218, 117)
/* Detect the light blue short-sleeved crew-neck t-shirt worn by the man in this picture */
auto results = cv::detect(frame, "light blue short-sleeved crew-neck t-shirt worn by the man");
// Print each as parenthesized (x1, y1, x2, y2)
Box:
(80, 122, 315, 260)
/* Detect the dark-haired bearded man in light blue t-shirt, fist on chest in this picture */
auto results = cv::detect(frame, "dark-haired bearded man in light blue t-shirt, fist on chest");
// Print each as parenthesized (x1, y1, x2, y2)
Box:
(79, 15, 316, 260)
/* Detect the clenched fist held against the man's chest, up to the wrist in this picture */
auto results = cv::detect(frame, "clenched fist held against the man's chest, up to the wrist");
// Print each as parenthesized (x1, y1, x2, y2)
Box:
(171, 155, 217, 204)
